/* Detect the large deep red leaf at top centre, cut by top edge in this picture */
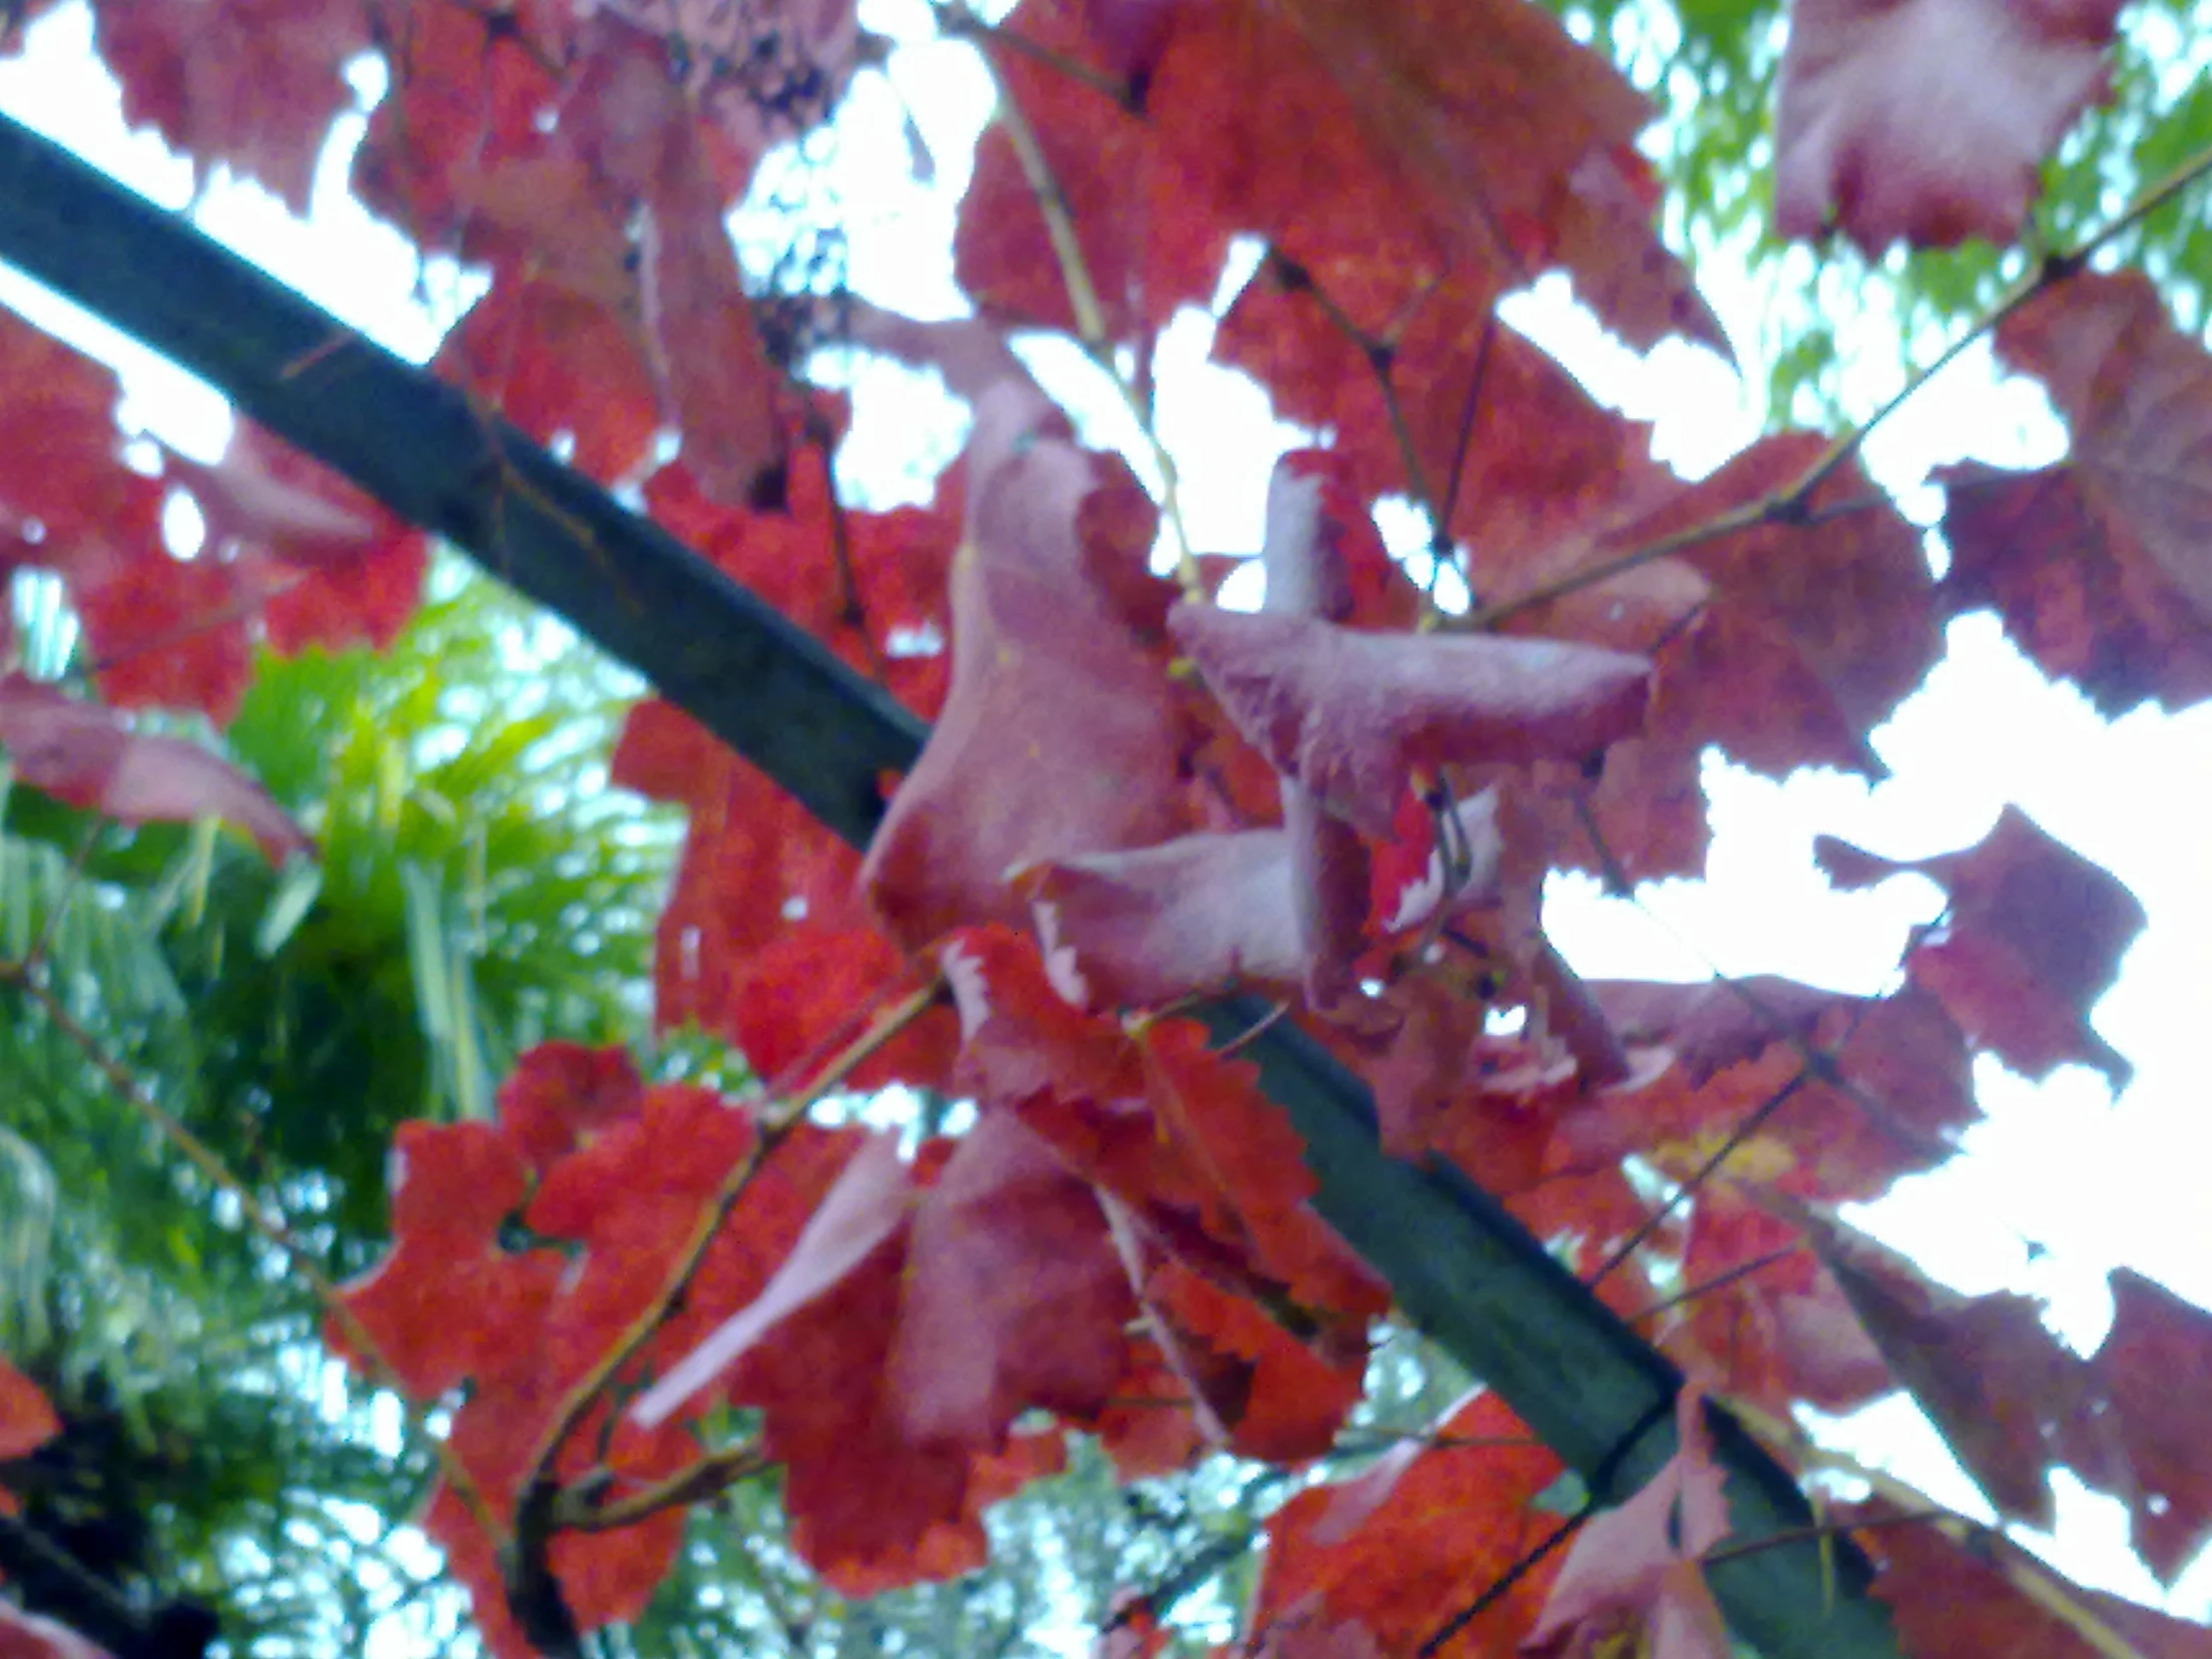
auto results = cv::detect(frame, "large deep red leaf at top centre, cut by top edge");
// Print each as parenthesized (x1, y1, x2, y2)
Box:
(1146, 0, 1719, 360)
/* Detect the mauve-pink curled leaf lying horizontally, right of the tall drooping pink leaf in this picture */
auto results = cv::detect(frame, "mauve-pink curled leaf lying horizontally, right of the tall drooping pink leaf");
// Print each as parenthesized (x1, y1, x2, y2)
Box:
(1168, 604, 1650, 836)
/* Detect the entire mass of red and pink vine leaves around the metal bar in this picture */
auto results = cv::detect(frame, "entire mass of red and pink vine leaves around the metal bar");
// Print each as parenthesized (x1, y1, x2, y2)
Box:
(0, 0, 2212, 1659)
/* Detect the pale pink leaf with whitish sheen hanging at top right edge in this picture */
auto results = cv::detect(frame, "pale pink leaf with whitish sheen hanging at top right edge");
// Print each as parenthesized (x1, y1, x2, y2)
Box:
(1774, 0, 2119, 255)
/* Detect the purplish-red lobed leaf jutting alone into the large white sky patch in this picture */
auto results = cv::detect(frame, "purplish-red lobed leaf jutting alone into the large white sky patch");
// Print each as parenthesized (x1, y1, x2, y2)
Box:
(1814, 808, 2146, 1086)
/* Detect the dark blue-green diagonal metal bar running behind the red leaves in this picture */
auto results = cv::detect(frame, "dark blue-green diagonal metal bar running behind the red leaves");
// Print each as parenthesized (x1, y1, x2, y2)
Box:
(0, 120, 1898, 1659)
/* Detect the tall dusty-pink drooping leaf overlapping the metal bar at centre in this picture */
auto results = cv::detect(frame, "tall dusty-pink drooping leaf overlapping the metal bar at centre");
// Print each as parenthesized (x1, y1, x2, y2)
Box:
(860, 380, 1188, 949)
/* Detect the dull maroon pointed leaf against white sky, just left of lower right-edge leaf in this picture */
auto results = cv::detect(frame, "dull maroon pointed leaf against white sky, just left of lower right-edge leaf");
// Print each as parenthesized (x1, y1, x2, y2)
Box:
(1796, 1212, 2086, 1528)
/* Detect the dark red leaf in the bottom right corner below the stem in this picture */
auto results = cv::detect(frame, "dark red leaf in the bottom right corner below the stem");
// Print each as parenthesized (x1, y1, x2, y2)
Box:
(1836, 1497, 2212, 1659)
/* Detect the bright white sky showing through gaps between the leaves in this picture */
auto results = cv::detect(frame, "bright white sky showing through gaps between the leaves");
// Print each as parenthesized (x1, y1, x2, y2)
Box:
(0, 0, 2212, 1617)
